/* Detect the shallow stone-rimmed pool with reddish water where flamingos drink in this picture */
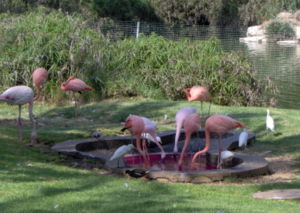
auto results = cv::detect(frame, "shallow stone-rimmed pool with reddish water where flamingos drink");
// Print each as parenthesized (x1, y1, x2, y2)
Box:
(52, 130, 269, 183)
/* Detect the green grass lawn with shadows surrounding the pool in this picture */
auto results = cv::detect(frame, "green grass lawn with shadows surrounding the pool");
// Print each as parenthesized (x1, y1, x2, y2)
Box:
(0, 99, 300, 213)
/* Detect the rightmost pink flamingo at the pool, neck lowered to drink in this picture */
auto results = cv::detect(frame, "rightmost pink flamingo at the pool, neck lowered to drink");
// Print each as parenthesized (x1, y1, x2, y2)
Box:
(192, 115, 246, 168)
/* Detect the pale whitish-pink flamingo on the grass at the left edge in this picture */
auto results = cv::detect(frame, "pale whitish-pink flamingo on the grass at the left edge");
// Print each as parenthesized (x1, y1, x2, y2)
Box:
(0, 86, 37, 144)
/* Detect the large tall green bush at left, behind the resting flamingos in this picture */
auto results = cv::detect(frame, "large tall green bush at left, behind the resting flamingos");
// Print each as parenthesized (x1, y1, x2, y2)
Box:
(0, 8, 108, 101)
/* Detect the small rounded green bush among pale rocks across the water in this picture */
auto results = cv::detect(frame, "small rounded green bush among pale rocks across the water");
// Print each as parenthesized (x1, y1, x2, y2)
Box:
(266, 20, 295, 41)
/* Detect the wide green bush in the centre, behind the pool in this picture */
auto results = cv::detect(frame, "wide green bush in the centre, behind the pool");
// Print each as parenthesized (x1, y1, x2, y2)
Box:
(105, 34, 263, 105)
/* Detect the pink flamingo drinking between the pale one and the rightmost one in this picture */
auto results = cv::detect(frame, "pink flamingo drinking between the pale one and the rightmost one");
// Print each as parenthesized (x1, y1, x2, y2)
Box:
(178, 113, 201, 167)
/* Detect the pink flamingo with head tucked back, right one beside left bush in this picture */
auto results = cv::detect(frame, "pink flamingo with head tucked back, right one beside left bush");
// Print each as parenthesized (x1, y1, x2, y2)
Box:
(60, 76, 94, 115)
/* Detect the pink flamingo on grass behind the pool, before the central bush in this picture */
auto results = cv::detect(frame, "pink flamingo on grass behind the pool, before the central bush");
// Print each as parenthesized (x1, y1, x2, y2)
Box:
(183, 86, 211, 115)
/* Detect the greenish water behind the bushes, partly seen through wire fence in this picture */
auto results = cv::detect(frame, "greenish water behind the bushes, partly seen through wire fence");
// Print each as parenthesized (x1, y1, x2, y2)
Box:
(99, 22, 300, 109)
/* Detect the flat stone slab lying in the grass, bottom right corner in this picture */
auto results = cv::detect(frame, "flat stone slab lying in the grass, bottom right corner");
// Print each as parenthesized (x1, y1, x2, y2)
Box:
(252, 189, 300, 200)
